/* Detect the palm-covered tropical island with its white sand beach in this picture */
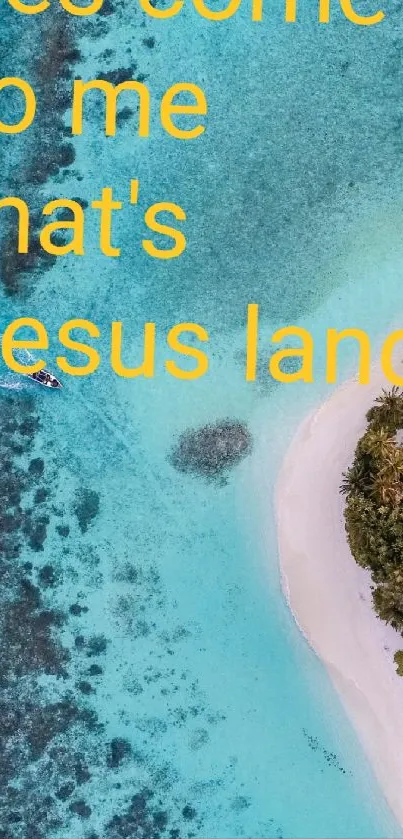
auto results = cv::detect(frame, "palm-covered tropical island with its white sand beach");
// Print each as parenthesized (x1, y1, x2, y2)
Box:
(275, 372, 403, 835)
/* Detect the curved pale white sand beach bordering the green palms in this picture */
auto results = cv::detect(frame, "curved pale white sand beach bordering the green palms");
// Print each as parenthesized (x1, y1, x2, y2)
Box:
(276, 370, 403, 825)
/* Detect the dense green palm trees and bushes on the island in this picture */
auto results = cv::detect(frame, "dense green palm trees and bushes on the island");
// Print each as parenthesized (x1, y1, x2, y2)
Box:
(340, 388, 403, 664)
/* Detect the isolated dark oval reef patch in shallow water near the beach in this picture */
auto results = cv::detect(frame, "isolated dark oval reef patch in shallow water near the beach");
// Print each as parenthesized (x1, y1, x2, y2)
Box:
(171, 419, 252, 479)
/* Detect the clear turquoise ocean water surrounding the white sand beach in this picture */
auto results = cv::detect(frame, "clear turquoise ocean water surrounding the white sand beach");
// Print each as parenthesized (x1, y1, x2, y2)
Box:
(0, 0, 403, 839)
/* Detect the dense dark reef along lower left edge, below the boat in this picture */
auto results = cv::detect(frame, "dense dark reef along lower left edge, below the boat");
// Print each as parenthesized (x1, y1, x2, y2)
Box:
(0, 394, 100, 839)
